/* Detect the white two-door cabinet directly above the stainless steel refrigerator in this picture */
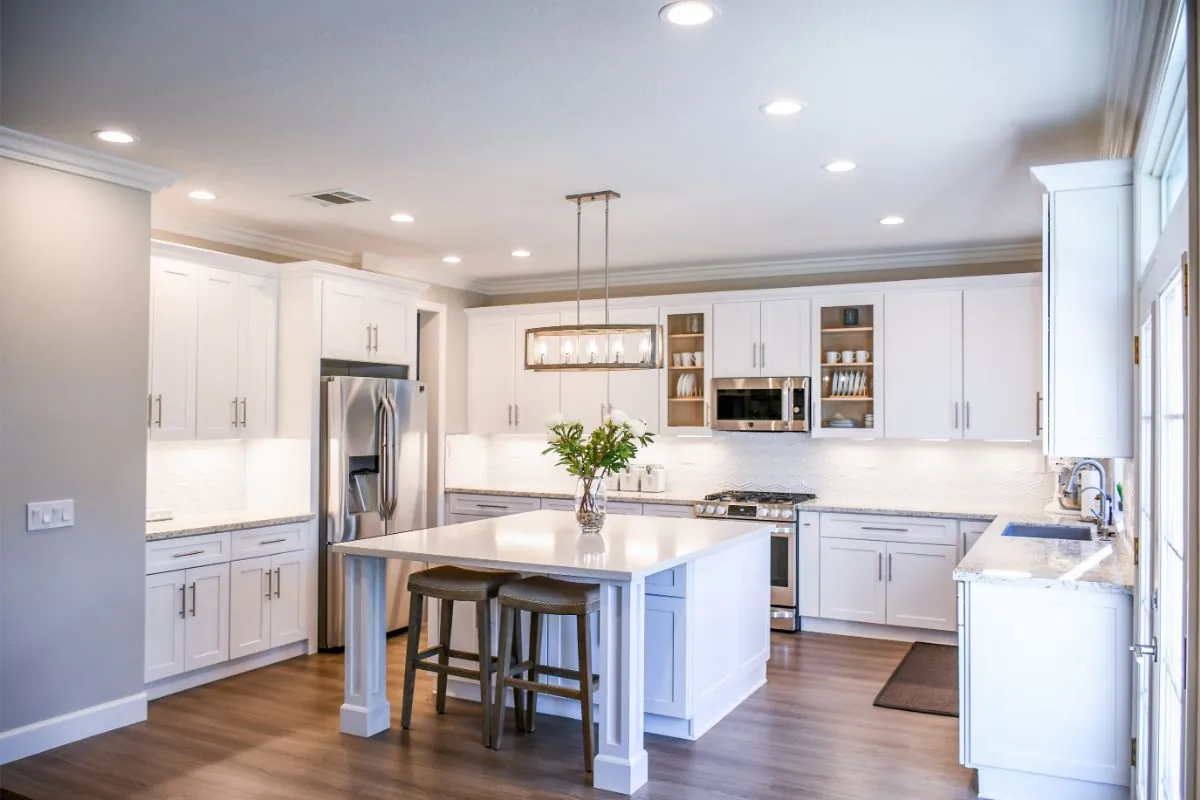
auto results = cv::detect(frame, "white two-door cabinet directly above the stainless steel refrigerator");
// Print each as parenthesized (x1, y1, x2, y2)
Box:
(320, 279, 416, 366)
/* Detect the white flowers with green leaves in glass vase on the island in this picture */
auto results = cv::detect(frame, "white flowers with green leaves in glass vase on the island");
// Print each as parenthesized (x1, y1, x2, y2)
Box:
(542, 410, 654, 533)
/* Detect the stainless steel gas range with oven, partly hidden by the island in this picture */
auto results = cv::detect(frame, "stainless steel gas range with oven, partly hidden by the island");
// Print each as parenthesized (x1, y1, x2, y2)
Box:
(692, 492, 817, 631)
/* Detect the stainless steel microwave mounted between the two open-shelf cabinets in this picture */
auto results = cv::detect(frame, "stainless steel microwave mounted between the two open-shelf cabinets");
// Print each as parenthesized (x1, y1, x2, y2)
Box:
(712, 378, 809, 431)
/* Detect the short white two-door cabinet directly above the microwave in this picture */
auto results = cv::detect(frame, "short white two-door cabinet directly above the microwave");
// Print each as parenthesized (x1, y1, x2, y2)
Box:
(713, 299, 811, 378)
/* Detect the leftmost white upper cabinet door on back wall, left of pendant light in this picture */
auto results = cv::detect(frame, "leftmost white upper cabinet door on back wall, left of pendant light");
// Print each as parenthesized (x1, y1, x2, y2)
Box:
(467, 317, 518, 435)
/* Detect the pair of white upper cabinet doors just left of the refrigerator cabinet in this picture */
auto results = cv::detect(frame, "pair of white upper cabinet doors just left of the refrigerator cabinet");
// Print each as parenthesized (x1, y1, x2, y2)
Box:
(196, 267, 278, 439)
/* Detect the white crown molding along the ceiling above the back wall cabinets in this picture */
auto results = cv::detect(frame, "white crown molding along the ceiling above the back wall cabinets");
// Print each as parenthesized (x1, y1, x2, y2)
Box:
(478, 241, 1042, 295)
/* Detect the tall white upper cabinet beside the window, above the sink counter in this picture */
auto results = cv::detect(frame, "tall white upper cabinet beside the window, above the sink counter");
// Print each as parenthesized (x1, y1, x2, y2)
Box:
(1033, 158, 1134, 458)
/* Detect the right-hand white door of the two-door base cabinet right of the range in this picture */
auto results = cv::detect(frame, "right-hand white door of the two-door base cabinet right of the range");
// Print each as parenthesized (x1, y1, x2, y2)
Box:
(886, 542, 959, 631)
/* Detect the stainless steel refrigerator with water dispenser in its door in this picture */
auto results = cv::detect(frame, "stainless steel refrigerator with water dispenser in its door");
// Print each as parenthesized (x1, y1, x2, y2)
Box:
(318, 377, 428, 649)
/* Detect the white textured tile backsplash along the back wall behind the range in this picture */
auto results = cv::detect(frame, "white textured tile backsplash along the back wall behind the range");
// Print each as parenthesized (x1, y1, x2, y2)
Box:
(446, 433, 1054, 511)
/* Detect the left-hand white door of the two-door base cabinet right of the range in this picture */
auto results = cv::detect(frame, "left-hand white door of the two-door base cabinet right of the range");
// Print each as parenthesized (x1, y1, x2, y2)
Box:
(821, 539, 887, 622)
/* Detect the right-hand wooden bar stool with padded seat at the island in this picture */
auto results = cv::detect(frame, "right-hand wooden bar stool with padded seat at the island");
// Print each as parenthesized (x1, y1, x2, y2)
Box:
(492, 576, 600, 772)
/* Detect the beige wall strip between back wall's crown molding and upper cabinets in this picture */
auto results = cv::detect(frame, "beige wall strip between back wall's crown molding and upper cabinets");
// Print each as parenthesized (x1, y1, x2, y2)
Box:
(480, 261, 1042, 306)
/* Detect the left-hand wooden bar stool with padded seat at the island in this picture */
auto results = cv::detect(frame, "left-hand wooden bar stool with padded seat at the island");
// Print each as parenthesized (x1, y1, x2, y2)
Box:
(401, 566, 523, 746)
